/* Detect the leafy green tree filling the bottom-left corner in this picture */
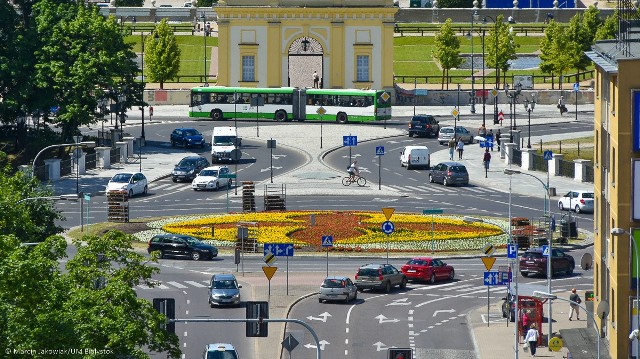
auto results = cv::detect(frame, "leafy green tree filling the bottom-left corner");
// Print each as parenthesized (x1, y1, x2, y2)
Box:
(0, 232, 181, 358)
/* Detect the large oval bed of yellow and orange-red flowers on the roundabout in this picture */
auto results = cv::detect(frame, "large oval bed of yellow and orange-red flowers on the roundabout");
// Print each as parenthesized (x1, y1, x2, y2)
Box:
(145, 211, 507, 252)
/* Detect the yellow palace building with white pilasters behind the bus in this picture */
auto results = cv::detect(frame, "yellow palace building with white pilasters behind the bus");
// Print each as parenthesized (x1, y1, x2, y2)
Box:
(216, 0, 397, 91)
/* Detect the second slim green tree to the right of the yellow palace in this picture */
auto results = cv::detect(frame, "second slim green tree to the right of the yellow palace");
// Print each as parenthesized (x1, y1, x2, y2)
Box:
(485, 15, 520, 88)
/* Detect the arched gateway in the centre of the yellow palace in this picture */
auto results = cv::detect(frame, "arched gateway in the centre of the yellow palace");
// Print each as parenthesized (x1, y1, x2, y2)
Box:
(288, 36, 324, 88)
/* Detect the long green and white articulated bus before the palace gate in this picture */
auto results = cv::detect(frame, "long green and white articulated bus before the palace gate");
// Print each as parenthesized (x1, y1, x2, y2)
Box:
(189, 86, 391, 123)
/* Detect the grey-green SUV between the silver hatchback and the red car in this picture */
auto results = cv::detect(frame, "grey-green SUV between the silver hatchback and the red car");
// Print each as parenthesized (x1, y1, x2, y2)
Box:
(355, 264, 407, 293)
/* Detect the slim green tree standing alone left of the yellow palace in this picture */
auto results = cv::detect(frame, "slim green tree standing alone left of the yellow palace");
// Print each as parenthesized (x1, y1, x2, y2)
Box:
(144, 19, 180, 88)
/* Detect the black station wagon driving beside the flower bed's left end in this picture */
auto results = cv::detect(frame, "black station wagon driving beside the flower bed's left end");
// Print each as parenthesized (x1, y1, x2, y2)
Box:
(147, 234, 218, 261)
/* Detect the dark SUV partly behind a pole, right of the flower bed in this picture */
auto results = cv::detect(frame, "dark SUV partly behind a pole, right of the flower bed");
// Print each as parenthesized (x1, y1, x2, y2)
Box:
(520, 247, 576, 277)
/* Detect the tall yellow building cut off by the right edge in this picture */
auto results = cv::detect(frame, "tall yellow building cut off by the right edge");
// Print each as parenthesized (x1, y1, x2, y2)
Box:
(587, 40, 640, 358)
